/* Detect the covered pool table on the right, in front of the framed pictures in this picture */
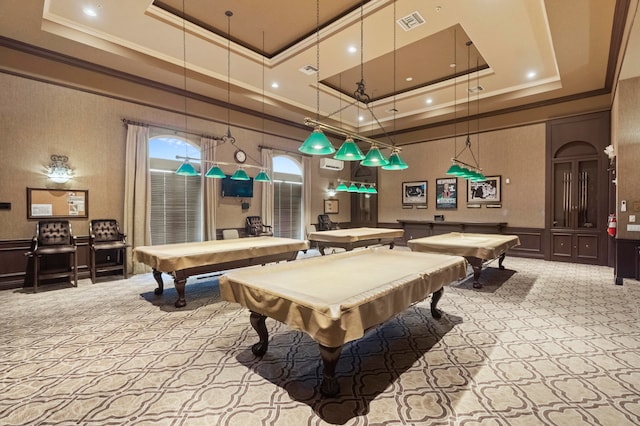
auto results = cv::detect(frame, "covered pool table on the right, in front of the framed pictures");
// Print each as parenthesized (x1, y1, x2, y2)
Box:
(407, 232, 520, 288)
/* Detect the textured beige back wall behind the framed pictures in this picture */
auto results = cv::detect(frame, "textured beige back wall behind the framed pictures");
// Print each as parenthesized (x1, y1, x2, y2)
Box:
(378, 124, 545, 228)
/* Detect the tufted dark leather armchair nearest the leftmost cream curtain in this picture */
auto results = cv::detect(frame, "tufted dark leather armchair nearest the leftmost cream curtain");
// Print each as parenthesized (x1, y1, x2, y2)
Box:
(89, 219, 129, 283)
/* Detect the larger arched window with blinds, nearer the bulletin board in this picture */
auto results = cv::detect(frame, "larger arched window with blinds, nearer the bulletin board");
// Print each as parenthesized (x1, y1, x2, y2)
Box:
(149, 136, 202, 245)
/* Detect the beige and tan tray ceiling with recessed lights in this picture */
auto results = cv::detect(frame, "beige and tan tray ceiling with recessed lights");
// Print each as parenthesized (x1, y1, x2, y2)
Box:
(0, 0, 640, 143)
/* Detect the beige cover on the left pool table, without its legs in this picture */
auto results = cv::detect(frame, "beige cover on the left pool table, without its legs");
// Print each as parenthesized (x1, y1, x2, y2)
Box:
(134, 237, 309, 273)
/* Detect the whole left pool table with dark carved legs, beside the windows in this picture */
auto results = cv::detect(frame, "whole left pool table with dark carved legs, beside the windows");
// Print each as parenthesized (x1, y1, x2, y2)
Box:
(133, 237, 309, 308)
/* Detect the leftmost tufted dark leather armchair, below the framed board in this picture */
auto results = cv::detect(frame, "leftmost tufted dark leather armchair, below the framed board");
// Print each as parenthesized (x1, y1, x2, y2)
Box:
(26, 220, 78, 292)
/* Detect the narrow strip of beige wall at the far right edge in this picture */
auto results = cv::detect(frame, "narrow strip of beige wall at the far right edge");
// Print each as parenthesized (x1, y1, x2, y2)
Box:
(612, 77, 640, 240)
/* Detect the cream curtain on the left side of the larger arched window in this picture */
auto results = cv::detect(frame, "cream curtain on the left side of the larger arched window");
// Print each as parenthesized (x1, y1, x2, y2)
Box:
(123, 123, 151, 274)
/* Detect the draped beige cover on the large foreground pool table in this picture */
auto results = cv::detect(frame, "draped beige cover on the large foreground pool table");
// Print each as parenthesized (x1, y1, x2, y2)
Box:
(220, 248, 467, 347)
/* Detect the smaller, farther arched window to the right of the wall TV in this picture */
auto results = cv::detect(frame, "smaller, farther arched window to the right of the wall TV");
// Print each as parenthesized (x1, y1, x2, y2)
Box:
(273, 155, 304, 239)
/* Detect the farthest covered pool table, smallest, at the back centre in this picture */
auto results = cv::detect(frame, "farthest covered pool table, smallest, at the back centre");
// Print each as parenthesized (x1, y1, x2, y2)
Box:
(307, 227, 404, 255)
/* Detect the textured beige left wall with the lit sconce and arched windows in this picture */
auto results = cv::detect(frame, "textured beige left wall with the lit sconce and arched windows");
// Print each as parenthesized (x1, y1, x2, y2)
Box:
(0, 73, 306, 240)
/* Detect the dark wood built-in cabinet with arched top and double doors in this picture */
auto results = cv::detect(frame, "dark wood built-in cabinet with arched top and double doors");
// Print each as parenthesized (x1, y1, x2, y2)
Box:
(545, 113, 610, 265)
